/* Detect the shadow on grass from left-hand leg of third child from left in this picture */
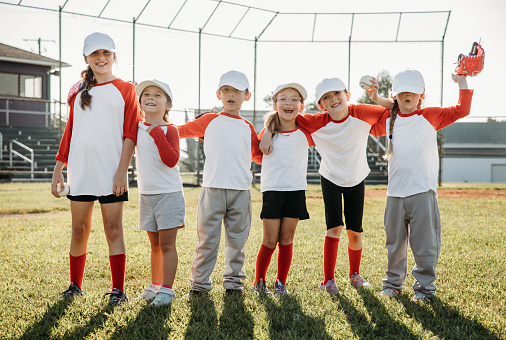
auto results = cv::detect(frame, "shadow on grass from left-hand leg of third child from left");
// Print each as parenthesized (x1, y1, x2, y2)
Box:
(185, 294, 218, 339)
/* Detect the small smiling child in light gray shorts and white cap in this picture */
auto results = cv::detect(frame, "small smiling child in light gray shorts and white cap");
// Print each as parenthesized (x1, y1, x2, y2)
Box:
(135, 79, 185, 306)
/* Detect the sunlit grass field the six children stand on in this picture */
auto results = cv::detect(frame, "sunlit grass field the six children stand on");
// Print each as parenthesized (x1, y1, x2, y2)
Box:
(0, 183, 506, 339)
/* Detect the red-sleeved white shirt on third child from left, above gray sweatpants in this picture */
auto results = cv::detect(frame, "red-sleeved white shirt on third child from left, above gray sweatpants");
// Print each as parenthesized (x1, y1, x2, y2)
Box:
(178, 112, 258, 190)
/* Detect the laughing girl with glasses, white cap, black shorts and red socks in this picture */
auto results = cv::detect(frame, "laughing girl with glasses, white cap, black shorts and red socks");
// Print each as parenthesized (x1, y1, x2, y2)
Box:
(253, 83, 314, 295)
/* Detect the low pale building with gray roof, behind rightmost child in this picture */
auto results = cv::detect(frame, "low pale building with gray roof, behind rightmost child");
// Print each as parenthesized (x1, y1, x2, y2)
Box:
(441, 121, 506, 183)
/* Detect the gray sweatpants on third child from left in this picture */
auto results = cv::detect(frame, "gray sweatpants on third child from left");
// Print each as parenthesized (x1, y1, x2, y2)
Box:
(191, 187, 251, 291)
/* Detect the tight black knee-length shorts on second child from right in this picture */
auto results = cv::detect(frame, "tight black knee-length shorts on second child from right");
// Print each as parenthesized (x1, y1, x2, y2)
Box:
(320, 176, 365, 233)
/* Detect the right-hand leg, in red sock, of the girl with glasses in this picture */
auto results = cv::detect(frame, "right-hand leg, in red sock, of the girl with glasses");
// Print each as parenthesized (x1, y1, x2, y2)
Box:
(277, 217, 299, 285)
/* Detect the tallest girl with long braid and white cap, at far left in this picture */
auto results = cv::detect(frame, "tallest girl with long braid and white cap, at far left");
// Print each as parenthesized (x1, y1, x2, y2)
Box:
(51, 32, 140, 305)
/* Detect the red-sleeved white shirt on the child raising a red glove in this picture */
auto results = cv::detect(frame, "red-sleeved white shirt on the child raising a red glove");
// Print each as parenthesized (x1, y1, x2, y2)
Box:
(371, 90, 473, 197)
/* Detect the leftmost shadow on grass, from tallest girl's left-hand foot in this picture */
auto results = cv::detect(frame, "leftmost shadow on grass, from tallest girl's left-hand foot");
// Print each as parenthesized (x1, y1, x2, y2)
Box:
(20, 299, 72, 340)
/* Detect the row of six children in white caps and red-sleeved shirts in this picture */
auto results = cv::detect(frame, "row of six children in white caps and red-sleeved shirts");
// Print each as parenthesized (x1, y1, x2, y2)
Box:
(51, 33, 472, 306)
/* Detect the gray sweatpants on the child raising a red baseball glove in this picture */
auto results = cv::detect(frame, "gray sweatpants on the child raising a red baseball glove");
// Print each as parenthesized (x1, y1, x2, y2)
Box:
(383, 190, 441, 296)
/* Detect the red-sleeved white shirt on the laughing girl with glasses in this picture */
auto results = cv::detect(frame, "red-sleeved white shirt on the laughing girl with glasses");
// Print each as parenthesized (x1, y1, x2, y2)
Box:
(253, 127, 314, 192)
